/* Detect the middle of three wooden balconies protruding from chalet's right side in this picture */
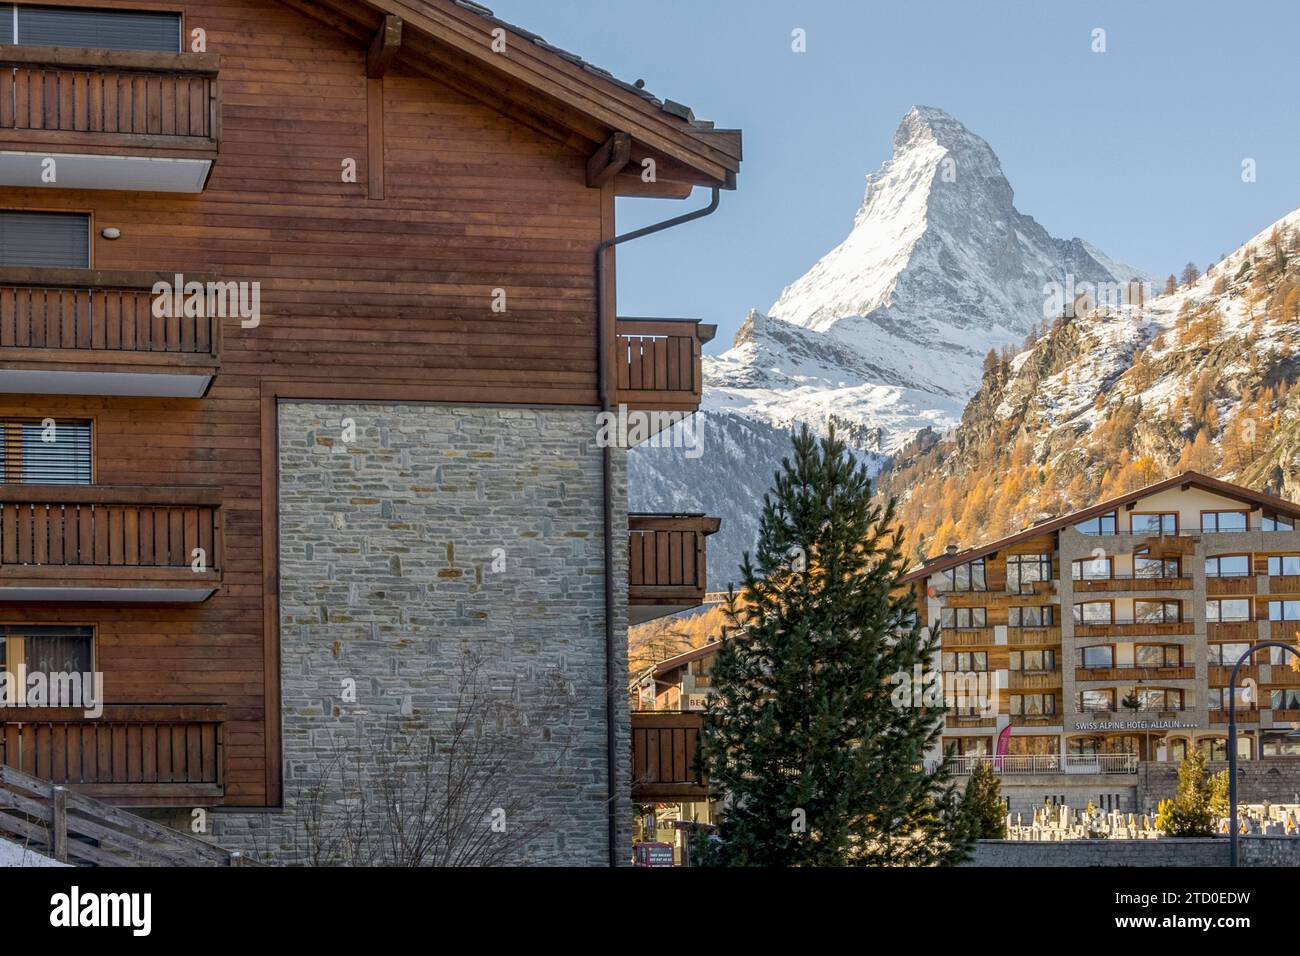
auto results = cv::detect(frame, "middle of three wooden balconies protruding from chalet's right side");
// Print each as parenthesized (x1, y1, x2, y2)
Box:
(628, 514, 722, 624)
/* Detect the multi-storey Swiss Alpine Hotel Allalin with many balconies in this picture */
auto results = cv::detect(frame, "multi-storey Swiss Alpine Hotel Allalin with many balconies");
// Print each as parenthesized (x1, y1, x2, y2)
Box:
(905, 472, 1300, 809)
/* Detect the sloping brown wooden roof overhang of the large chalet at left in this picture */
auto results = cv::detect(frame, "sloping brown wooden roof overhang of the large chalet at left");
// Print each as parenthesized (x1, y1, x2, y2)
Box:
(289, 0, 741, 195)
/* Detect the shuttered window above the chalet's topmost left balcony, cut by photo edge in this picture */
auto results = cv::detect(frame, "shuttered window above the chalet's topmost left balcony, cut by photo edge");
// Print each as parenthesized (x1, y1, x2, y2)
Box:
(0, 4, 181, 53)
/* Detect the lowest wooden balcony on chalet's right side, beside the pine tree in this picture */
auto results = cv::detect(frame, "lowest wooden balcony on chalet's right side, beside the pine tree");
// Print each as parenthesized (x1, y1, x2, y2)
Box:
(632, 710, 709, 803)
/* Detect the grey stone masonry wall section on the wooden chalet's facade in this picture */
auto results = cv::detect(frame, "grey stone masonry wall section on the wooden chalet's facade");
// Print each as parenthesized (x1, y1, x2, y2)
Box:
(213, 403, 632, 865)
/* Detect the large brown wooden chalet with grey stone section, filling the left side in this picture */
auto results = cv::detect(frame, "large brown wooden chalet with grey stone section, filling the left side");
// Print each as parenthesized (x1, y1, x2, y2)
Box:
(0, 0, 741, 865)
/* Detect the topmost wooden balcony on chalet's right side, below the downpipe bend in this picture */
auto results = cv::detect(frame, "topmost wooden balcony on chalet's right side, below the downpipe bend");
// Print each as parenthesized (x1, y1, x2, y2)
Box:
(614, 319, 718, 416)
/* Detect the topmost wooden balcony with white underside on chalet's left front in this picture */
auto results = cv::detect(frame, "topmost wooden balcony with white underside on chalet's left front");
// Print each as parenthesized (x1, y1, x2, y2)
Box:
(0, 46, 221, 193)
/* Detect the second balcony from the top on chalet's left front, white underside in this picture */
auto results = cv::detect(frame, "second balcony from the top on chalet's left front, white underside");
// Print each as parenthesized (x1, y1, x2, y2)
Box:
(0, 268, 221, 398)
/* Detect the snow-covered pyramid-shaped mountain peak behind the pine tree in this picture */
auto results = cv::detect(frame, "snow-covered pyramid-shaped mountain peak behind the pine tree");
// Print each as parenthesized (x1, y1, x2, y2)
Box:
(629, 107, 1151, 587)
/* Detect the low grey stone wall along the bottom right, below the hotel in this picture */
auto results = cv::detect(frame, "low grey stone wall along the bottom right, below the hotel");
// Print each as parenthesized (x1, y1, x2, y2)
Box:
(965, 836, 1300, 866)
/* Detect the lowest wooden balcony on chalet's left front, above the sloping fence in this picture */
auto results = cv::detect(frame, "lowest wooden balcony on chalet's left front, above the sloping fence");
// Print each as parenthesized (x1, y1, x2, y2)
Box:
(0, 705, 225, 806)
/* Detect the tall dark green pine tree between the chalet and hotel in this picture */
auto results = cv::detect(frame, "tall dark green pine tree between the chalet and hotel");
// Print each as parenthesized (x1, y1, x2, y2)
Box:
(699, 427, 970, 866)
